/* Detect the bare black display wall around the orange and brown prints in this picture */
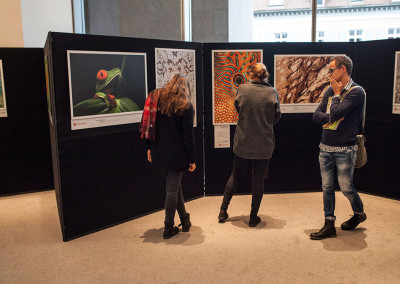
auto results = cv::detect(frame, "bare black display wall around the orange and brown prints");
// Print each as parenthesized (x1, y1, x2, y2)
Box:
(203, 40, 400, 198)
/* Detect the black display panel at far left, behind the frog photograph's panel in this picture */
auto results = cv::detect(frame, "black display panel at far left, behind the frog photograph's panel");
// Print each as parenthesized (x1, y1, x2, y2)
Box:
(0, 48, 54, 196)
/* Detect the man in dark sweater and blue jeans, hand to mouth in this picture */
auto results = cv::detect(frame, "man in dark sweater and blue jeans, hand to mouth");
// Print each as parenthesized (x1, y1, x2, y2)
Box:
(310, 56, 367, 240)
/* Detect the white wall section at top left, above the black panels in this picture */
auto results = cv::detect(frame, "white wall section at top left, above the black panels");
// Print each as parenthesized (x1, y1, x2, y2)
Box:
(21, 0, 73, 47)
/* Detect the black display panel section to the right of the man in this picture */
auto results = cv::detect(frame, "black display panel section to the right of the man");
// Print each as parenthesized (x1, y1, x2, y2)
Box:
(354, 39, 400, 199)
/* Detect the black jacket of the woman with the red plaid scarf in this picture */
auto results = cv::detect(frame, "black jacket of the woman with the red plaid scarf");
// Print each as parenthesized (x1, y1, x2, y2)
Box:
(146, 105, 195, 171)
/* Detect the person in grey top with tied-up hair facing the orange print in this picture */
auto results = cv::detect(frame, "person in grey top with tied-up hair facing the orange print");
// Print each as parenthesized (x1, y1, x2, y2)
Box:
(218, 63, 281, 227)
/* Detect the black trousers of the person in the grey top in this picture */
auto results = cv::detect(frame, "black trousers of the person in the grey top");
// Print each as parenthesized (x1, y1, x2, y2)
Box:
(221, 155, 269, 215)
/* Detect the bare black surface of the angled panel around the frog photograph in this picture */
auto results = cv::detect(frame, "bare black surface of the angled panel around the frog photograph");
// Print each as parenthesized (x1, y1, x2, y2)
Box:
(45, 33, 204, 240)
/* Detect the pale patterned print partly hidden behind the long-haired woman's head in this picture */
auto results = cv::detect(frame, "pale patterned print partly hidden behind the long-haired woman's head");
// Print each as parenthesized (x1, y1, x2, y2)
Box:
(155, 48, 197, 126)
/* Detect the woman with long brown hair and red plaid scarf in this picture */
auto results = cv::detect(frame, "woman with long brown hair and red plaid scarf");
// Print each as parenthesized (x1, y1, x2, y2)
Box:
(141, 74, 196, 239)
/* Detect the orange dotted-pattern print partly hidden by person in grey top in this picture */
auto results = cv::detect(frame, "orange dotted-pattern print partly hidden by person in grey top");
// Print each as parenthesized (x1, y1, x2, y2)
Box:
(212, 49, 263, 125)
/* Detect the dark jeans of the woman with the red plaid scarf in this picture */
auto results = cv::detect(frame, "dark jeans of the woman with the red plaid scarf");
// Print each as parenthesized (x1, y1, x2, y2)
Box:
(161, 169, 186, 227)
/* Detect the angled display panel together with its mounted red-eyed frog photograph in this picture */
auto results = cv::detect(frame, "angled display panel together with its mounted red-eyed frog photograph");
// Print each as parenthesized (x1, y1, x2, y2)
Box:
(45, 33, 204, 241)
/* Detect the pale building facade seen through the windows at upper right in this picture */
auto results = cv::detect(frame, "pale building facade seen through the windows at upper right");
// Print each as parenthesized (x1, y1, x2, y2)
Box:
(253, 0, 400, 42)
